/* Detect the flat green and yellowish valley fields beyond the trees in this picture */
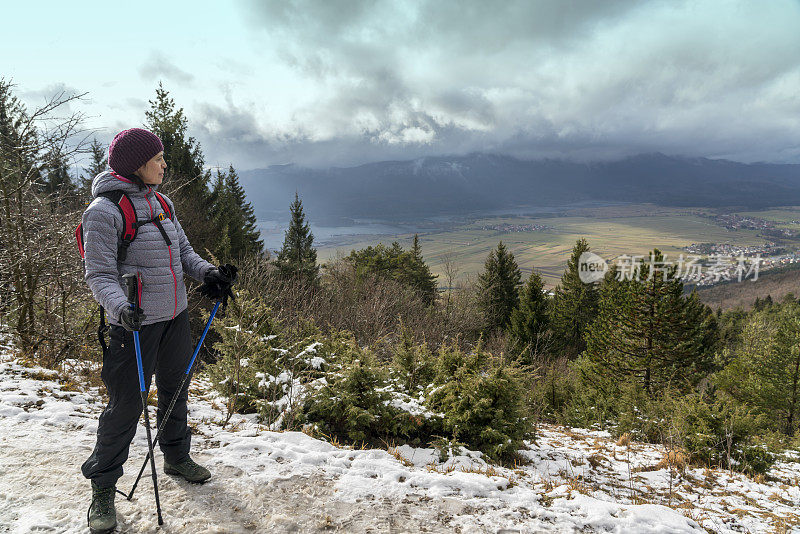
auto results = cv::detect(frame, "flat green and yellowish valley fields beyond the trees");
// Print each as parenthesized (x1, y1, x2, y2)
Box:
(318, 205, 800, 286)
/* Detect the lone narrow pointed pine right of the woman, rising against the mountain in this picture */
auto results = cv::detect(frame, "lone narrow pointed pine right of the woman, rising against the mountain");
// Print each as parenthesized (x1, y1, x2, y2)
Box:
(275, 192, 319, 282)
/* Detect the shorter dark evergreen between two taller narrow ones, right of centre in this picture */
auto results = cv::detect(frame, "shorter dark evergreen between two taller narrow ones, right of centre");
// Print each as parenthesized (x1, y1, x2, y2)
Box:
(508, 270, 549, 363)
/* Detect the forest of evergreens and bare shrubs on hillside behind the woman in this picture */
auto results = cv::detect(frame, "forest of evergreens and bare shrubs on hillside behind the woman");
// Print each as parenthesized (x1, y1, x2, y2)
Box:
(0, 76, 800, 476)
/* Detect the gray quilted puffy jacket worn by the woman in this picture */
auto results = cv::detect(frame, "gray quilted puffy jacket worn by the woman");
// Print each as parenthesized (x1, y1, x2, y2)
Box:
(83, 171, 214, 324)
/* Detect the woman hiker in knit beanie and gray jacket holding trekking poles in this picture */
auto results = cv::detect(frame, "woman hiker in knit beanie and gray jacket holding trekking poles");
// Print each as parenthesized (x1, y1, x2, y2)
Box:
(81, 128, 236, 533)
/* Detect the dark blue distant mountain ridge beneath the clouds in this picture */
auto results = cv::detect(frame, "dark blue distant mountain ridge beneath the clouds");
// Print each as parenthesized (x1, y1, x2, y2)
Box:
(240, 153, 800, 224)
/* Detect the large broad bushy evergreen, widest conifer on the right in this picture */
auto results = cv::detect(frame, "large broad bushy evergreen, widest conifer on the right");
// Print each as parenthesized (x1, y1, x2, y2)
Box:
(586, 249, 717, 393)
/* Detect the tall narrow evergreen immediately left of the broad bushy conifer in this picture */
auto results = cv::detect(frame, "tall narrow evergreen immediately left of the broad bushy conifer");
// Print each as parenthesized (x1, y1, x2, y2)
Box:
(550, 239, 598, 357)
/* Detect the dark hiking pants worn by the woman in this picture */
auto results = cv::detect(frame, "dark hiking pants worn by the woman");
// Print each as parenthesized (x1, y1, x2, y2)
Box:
(81, 310, 192, 487)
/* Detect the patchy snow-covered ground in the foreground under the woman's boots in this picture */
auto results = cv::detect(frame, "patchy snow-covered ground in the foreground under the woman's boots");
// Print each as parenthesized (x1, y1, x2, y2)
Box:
(0, 353, 800, 533)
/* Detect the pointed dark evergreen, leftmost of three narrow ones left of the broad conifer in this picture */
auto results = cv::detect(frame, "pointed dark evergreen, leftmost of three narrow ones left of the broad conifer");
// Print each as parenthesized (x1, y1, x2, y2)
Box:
(478, 241, 522, 331)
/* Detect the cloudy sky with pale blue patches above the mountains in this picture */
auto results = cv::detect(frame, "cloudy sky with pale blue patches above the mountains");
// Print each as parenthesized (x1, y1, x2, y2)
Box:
(0, 0, 800, 169)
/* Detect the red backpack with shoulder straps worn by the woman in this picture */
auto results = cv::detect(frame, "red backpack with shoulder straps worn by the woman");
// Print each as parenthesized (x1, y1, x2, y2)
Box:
(75, 190, 173, 356)
